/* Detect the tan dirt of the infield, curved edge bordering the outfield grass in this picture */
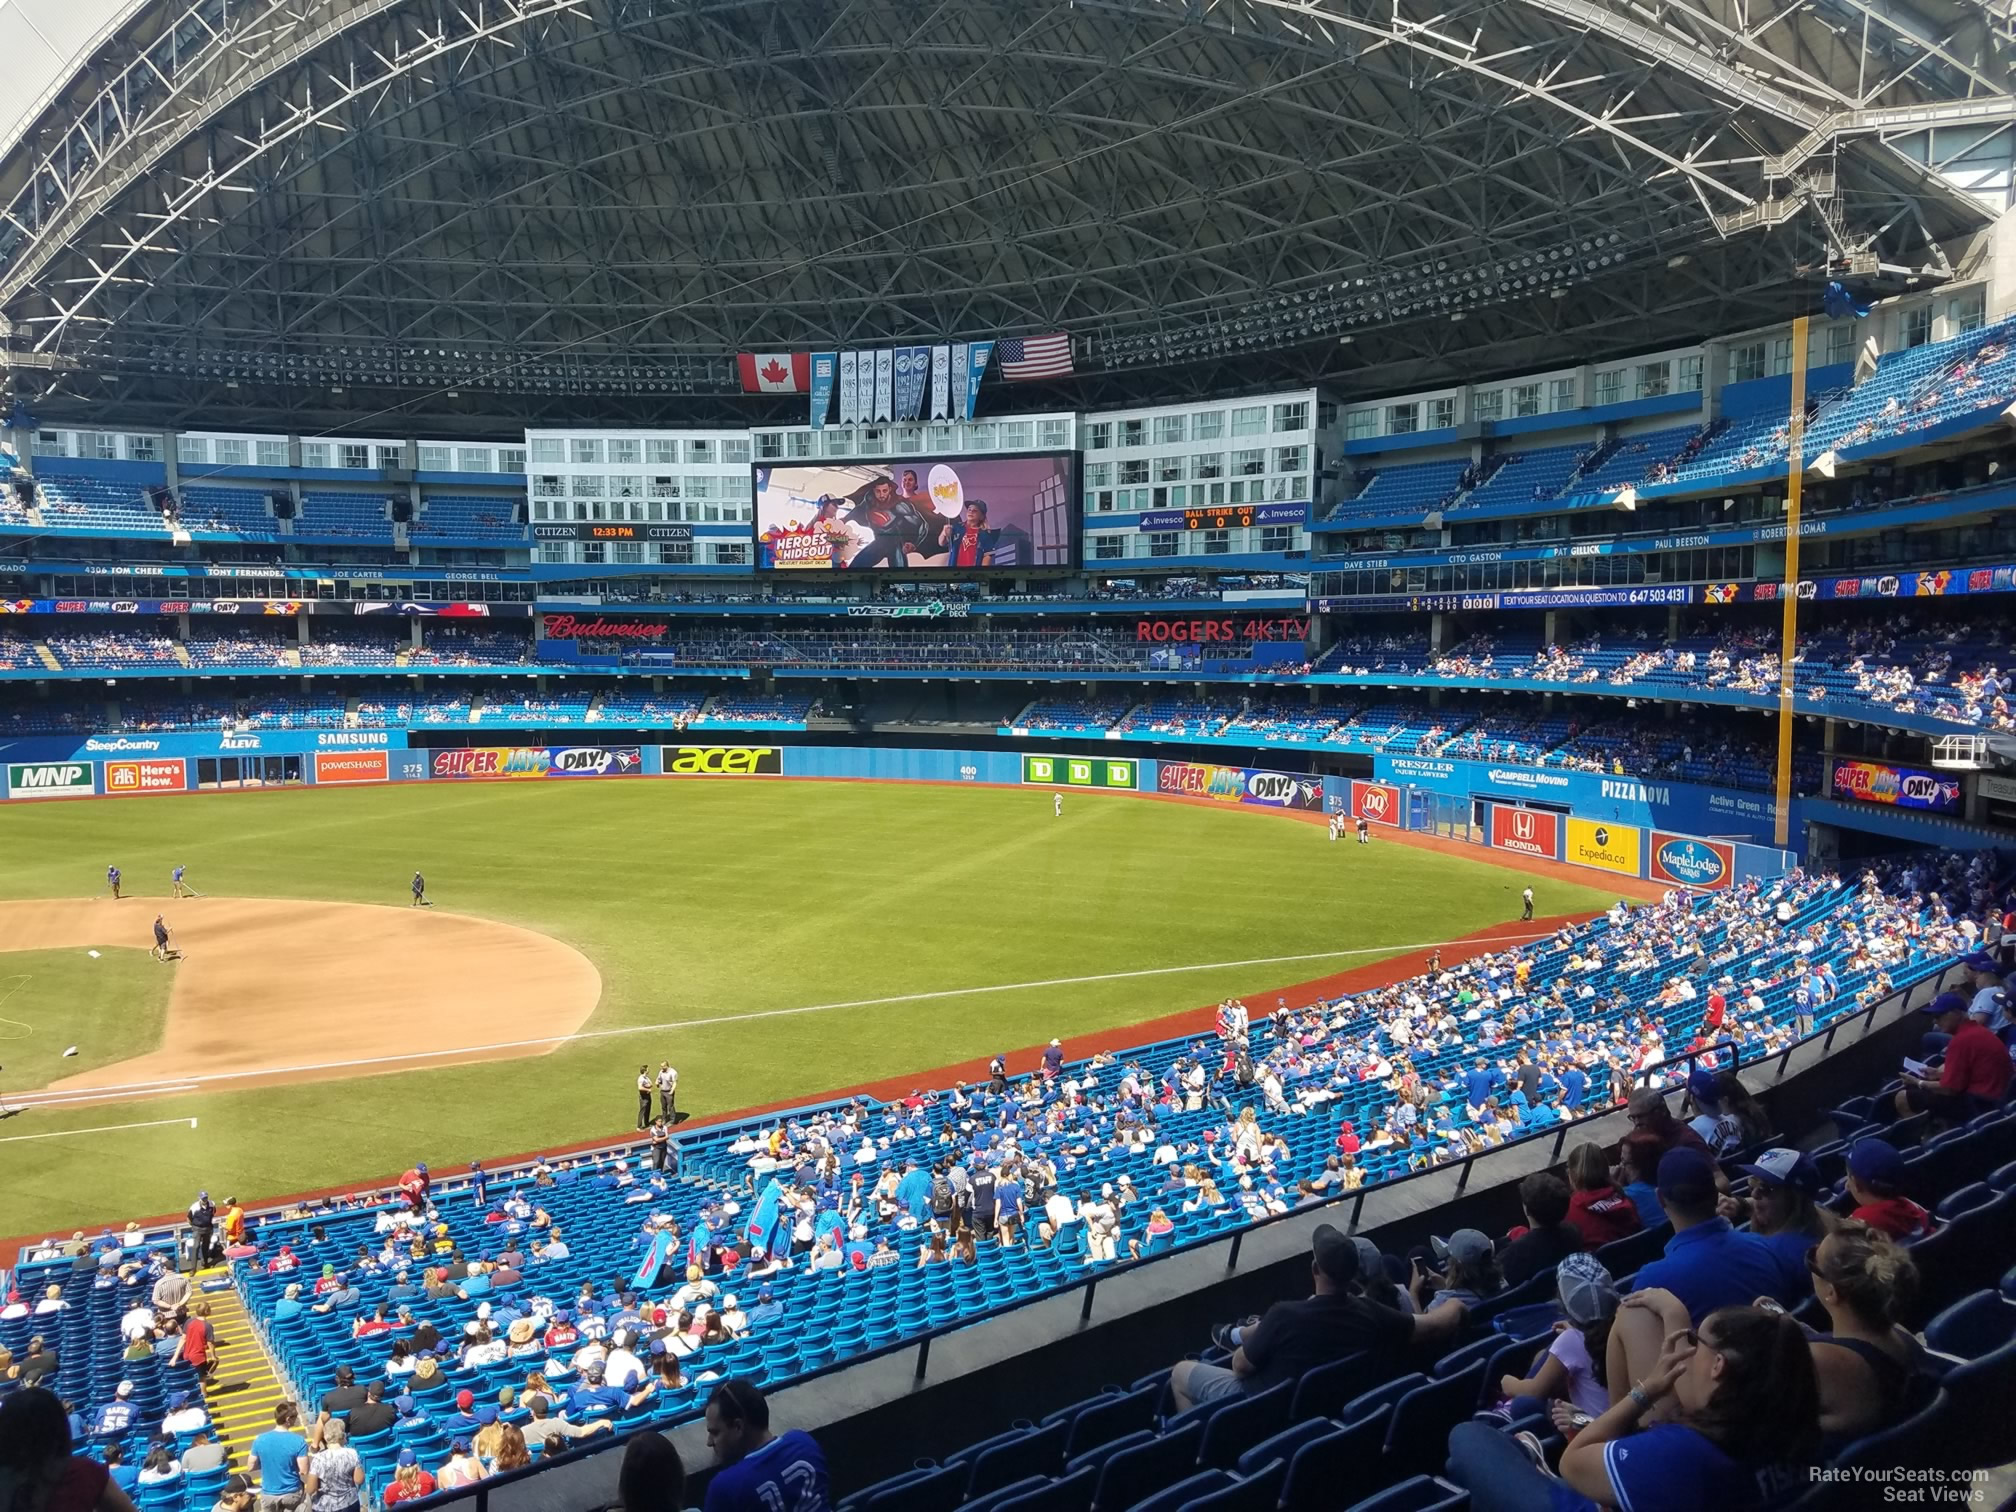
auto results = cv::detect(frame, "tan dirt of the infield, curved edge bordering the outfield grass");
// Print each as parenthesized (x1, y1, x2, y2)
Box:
(0, 897, 603, 1095)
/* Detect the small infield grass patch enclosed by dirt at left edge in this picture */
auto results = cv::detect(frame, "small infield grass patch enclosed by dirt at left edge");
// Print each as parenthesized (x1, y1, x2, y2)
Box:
(0, 941, 173, 1088)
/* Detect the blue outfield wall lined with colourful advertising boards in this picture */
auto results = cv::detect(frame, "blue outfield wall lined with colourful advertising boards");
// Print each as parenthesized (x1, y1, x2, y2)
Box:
(0, 730, 1802, 889)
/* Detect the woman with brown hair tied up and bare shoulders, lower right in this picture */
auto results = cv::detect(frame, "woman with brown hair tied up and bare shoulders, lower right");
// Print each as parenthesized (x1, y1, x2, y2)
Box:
(1806, 1222, 1939, 1447)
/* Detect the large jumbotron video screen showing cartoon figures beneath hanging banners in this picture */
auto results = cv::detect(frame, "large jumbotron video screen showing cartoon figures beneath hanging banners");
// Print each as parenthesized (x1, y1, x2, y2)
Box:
(756, 452, 1079, 573)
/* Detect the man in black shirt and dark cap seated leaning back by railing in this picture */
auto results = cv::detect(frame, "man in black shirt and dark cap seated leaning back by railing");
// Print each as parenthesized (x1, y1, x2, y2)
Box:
(1169, 1224, 1488, 1411)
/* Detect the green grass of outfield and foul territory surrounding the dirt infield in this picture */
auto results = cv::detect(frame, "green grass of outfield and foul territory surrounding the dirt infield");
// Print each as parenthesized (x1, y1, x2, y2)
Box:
(0, 780, 1611, 1234)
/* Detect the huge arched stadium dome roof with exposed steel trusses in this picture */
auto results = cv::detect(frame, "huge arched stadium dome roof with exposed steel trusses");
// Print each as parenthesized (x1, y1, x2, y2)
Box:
(0, 0, 2016, 431)
